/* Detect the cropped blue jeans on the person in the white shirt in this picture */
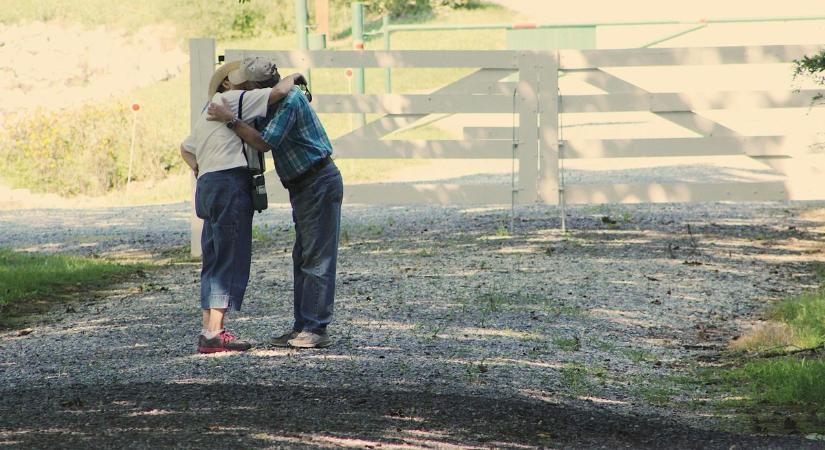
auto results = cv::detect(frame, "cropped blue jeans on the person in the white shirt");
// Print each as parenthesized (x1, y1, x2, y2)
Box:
(195, 167, 252, 311)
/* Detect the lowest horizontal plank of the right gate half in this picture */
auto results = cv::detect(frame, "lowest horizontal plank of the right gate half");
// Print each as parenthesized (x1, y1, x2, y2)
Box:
(564, 181, 789, 204)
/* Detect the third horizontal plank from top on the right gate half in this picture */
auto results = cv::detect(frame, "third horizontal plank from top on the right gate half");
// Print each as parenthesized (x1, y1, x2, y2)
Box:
(562, 136, 801, 159)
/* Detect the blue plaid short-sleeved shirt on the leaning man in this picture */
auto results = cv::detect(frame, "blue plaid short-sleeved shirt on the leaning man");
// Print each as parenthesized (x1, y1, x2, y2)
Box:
(261, 87, 332, 181)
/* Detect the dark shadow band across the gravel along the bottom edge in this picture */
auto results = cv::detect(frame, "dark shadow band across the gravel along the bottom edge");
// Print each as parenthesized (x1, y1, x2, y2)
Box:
(0, 383, 822, 449)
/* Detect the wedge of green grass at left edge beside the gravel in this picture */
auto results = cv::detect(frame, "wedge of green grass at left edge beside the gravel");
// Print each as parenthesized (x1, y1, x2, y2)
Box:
(0, 249, 146, 328)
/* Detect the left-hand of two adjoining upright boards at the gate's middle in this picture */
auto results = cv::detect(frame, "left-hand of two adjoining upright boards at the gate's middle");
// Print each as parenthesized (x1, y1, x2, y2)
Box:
(516, 52, 539, 205)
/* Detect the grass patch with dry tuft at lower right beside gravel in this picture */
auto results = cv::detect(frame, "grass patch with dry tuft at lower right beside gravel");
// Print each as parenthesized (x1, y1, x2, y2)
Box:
(710, 269, 825, 432)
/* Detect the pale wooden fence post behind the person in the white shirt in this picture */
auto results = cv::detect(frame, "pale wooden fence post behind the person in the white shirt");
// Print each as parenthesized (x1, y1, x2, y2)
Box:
(189, 39, 215, 257)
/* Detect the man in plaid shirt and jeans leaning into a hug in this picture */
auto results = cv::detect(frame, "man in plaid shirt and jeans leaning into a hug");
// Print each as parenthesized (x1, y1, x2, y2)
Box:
(208, 74, 344, 348)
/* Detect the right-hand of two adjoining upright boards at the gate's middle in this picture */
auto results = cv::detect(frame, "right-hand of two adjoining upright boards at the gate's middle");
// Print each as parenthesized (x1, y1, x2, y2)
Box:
(539, 52, 564, 205)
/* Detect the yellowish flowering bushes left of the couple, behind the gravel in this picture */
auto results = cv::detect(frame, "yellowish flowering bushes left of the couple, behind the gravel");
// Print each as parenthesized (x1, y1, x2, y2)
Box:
(0, 103, 182, 196)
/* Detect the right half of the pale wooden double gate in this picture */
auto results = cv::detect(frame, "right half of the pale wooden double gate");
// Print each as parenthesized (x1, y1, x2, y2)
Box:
(558, 45, 825, 204)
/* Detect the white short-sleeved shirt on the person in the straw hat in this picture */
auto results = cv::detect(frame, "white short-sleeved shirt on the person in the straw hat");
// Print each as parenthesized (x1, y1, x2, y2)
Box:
(183, 88, 272, 178)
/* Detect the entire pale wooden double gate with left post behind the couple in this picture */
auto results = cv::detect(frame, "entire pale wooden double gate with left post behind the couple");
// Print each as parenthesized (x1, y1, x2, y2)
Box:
(190, 39, 825, 253)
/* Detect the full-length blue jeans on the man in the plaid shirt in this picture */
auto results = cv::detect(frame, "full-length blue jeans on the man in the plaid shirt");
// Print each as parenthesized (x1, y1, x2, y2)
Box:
(289, 164, 344, 333)
